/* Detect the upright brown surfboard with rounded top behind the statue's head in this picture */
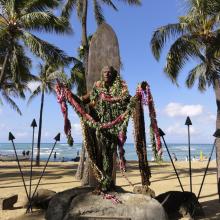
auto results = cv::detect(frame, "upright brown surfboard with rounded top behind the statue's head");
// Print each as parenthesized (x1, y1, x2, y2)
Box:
(87, 23, 121, 91)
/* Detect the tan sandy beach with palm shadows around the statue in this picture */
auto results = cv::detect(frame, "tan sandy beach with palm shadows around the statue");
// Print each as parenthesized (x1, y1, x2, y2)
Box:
(0, 161, 220, 220)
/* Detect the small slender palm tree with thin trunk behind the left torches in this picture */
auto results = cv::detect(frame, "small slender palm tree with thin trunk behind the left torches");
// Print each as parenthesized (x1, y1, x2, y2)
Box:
(28, 63, 59, 166)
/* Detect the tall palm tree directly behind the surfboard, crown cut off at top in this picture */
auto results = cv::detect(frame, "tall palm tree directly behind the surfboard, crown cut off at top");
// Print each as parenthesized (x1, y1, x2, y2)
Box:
(62, 0, 141, 81)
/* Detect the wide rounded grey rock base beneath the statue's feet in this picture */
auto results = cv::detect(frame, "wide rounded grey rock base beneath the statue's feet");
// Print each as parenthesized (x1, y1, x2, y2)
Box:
(46, 187, 167, 220)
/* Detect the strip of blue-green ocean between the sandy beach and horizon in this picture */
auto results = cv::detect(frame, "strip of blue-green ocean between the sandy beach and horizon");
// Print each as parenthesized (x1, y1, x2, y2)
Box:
(0, 143, 216, 161)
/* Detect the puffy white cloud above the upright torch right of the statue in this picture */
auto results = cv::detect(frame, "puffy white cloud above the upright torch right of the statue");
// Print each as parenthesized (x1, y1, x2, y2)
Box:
(165, 102, 203, 117)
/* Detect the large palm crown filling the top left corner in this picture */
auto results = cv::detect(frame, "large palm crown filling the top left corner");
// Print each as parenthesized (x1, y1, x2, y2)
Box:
(0, 0, 71, 85)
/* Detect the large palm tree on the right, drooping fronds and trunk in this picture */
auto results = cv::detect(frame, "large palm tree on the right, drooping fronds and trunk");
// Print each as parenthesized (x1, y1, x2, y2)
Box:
(151, 0, 220, 199)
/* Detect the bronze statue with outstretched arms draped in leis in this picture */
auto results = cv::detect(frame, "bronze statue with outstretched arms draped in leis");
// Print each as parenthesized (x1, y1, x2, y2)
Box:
(56, 66, 161, 191)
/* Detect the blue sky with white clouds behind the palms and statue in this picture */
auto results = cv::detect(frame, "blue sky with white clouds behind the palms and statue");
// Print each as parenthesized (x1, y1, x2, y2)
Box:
(0, 0, 216, 143)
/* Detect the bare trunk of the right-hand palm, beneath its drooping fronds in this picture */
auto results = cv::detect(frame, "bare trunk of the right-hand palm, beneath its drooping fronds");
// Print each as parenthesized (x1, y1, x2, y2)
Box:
(214, 79, 220, 200)
